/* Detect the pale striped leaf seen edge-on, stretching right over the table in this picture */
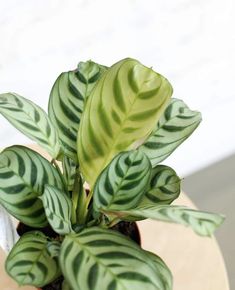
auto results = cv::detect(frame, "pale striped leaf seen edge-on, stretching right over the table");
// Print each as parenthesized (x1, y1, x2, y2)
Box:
(119, 205, 224, 236)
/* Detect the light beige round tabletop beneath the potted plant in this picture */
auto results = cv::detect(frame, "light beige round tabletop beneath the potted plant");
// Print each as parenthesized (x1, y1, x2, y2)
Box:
(0, 145, 229, 290)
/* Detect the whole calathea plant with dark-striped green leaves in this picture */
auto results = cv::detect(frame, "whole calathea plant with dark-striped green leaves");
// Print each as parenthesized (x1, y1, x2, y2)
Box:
(0, 59, 223, 290)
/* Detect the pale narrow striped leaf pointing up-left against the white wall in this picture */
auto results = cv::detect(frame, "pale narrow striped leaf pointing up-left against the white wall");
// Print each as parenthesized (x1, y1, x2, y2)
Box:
(0, 93, 60, 158)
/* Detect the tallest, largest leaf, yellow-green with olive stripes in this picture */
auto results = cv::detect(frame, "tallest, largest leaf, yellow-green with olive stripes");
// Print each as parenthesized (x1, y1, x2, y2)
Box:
(78, 59, 172, 188)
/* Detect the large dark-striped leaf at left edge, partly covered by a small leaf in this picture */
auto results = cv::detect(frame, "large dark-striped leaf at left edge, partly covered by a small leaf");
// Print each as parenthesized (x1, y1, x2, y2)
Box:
(0, 146, 63, 227)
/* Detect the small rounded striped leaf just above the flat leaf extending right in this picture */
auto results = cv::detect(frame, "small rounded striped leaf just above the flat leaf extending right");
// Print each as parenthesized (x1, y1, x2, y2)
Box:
(141, 165, 180, 204)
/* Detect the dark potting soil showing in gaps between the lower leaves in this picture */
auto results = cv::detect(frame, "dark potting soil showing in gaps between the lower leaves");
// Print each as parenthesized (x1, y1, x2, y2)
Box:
(17, 221, 141, 290)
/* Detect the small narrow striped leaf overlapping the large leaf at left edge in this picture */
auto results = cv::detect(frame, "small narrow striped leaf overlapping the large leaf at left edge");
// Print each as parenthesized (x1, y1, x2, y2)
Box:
(41, 184, 73, 235)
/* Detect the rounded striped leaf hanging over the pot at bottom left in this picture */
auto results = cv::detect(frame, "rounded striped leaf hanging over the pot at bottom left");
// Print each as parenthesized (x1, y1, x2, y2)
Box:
(5, 231, 60, 287)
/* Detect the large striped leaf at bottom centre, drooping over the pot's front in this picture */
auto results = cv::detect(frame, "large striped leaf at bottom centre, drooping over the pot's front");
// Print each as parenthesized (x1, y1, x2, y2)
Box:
(60, 227, 172, 290)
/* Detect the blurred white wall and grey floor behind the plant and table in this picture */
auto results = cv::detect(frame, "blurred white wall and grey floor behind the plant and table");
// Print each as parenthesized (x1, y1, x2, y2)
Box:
(0, 0, 235, 290)
